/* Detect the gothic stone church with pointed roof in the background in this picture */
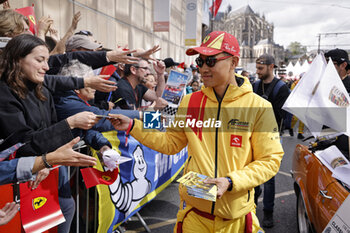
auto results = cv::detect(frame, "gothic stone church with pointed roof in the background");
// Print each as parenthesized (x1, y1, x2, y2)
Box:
(213, 5, 284, 71)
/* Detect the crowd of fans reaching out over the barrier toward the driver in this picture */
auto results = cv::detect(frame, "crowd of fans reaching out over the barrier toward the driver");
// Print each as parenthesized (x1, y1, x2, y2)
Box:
(0, 1, 349, 232)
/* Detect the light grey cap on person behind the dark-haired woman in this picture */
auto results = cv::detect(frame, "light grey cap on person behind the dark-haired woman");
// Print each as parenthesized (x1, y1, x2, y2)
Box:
(66, 35, 102, 52)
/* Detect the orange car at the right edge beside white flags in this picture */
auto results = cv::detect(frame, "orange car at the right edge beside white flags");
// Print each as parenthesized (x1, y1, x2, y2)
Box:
(291, 139, 350, 233)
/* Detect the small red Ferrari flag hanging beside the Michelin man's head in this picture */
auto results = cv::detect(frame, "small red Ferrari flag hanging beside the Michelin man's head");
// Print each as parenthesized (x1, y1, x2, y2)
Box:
(80, 167, 119, 188)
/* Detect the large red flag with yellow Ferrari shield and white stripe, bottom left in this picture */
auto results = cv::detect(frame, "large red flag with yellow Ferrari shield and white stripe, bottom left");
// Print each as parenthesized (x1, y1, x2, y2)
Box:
(19, 169, 65, 232)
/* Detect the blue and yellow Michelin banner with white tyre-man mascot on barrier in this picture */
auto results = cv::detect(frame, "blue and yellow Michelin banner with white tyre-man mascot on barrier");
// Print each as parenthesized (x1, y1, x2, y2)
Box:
(93, 131, 187, 233)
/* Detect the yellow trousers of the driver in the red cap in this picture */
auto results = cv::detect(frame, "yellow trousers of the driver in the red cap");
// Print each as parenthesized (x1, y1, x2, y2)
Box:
(174, 206, 264, 233)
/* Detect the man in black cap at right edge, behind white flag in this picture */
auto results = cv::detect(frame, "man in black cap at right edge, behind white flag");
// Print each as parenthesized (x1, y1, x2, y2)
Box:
(324, 49, 350, 94)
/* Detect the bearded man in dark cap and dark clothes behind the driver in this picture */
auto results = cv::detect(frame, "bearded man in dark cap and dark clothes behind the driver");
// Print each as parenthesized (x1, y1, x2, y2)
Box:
(253, 54, 290, 228)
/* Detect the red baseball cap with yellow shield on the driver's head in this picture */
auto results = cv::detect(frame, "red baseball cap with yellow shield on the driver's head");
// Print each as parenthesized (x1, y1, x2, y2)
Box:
(186, 31, 240, 57)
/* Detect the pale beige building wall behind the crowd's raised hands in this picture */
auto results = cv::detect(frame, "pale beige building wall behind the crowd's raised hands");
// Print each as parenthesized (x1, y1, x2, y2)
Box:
(8, 0, 203, 64)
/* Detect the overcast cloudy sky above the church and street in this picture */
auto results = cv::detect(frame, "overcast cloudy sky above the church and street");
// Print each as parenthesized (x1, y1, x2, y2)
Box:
(219, 0, 350, 50)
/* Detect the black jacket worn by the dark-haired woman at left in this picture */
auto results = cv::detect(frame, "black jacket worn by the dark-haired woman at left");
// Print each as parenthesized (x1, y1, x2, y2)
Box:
(0, 78, 73, 157)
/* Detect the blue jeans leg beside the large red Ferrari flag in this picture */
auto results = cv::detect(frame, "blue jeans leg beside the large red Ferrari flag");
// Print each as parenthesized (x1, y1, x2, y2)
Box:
(58, 197, 75, 233)
